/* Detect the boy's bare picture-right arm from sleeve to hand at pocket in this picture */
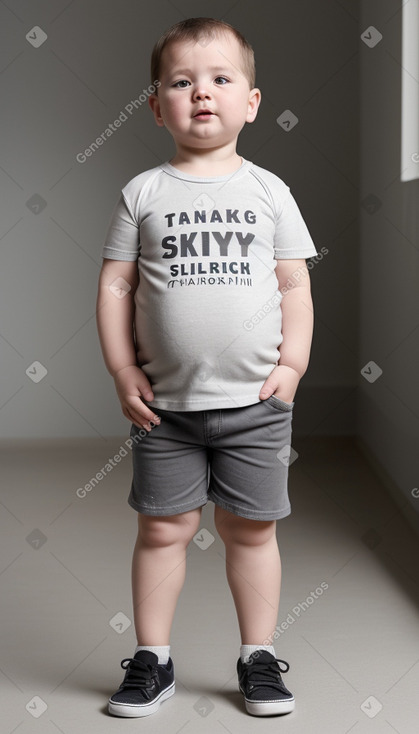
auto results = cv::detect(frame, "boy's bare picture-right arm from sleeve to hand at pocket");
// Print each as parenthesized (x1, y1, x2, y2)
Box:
(259, 259, 314, 403)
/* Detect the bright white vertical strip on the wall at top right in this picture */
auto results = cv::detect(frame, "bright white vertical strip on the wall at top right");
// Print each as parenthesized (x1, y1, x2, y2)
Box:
(401, 0, 419, 181)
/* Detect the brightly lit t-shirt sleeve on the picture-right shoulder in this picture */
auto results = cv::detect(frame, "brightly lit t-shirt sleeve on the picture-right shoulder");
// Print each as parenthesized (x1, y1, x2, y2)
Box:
(274, 189, 317, 260)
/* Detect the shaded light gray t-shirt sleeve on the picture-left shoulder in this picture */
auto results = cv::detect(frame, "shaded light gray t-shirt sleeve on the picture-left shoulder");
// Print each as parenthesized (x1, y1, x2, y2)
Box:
(102, 193, 140, 261)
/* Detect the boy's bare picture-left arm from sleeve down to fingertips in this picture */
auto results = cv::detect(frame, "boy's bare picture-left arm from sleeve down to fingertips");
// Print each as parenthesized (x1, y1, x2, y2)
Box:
(96, 258, 161, 430)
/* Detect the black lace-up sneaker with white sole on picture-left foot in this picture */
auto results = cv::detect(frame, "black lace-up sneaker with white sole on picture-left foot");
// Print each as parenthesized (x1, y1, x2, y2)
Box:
(108, 650, 175, 717)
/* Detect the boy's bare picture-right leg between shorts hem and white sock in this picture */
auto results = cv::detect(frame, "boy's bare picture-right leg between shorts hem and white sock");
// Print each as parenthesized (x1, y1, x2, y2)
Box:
(214, 505, 281, 645)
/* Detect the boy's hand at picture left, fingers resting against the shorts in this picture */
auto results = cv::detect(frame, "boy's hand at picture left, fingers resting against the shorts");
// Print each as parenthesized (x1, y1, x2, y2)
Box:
(113, 365, 160, 431)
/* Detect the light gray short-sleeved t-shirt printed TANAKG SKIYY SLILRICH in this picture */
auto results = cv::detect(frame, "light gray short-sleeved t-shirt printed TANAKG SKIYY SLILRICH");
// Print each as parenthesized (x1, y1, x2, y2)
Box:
(102, 159, 317, 411)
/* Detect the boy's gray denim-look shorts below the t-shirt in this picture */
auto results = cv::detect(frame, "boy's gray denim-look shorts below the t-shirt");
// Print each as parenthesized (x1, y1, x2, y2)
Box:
(128, 395, 294, 520)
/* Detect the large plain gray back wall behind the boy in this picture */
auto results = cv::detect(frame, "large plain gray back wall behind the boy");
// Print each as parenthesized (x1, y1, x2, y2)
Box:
(0, 0, 359, 438)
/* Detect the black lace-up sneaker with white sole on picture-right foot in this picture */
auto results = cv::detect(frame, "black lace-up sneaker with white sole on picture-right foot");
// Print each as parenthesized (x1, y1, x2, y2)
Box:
(237, 650, 295, 716)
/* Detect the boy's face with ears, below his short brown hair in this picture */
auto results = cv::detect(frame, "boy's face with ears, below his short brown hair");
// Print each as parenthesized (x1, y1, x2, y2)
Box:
(149, 33, 261, 149)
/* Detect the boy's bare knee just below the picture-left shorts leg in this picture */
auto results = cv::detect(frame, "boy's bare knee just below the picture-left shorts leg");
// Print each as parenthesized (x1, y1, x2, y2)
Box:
(138, 511, 201, 548)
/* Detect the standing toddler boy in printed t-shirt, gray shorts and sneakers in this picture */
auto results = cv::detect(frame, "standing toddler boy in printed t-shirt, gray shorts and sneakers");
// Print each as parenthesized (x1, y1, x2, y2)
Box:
(97, 18, 317, 717)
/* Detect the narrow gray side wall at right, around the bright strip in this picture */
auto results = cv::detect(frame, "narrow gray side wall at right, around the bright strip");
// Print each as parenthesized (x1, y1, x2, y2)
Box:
(357, 0, 419, 528)
